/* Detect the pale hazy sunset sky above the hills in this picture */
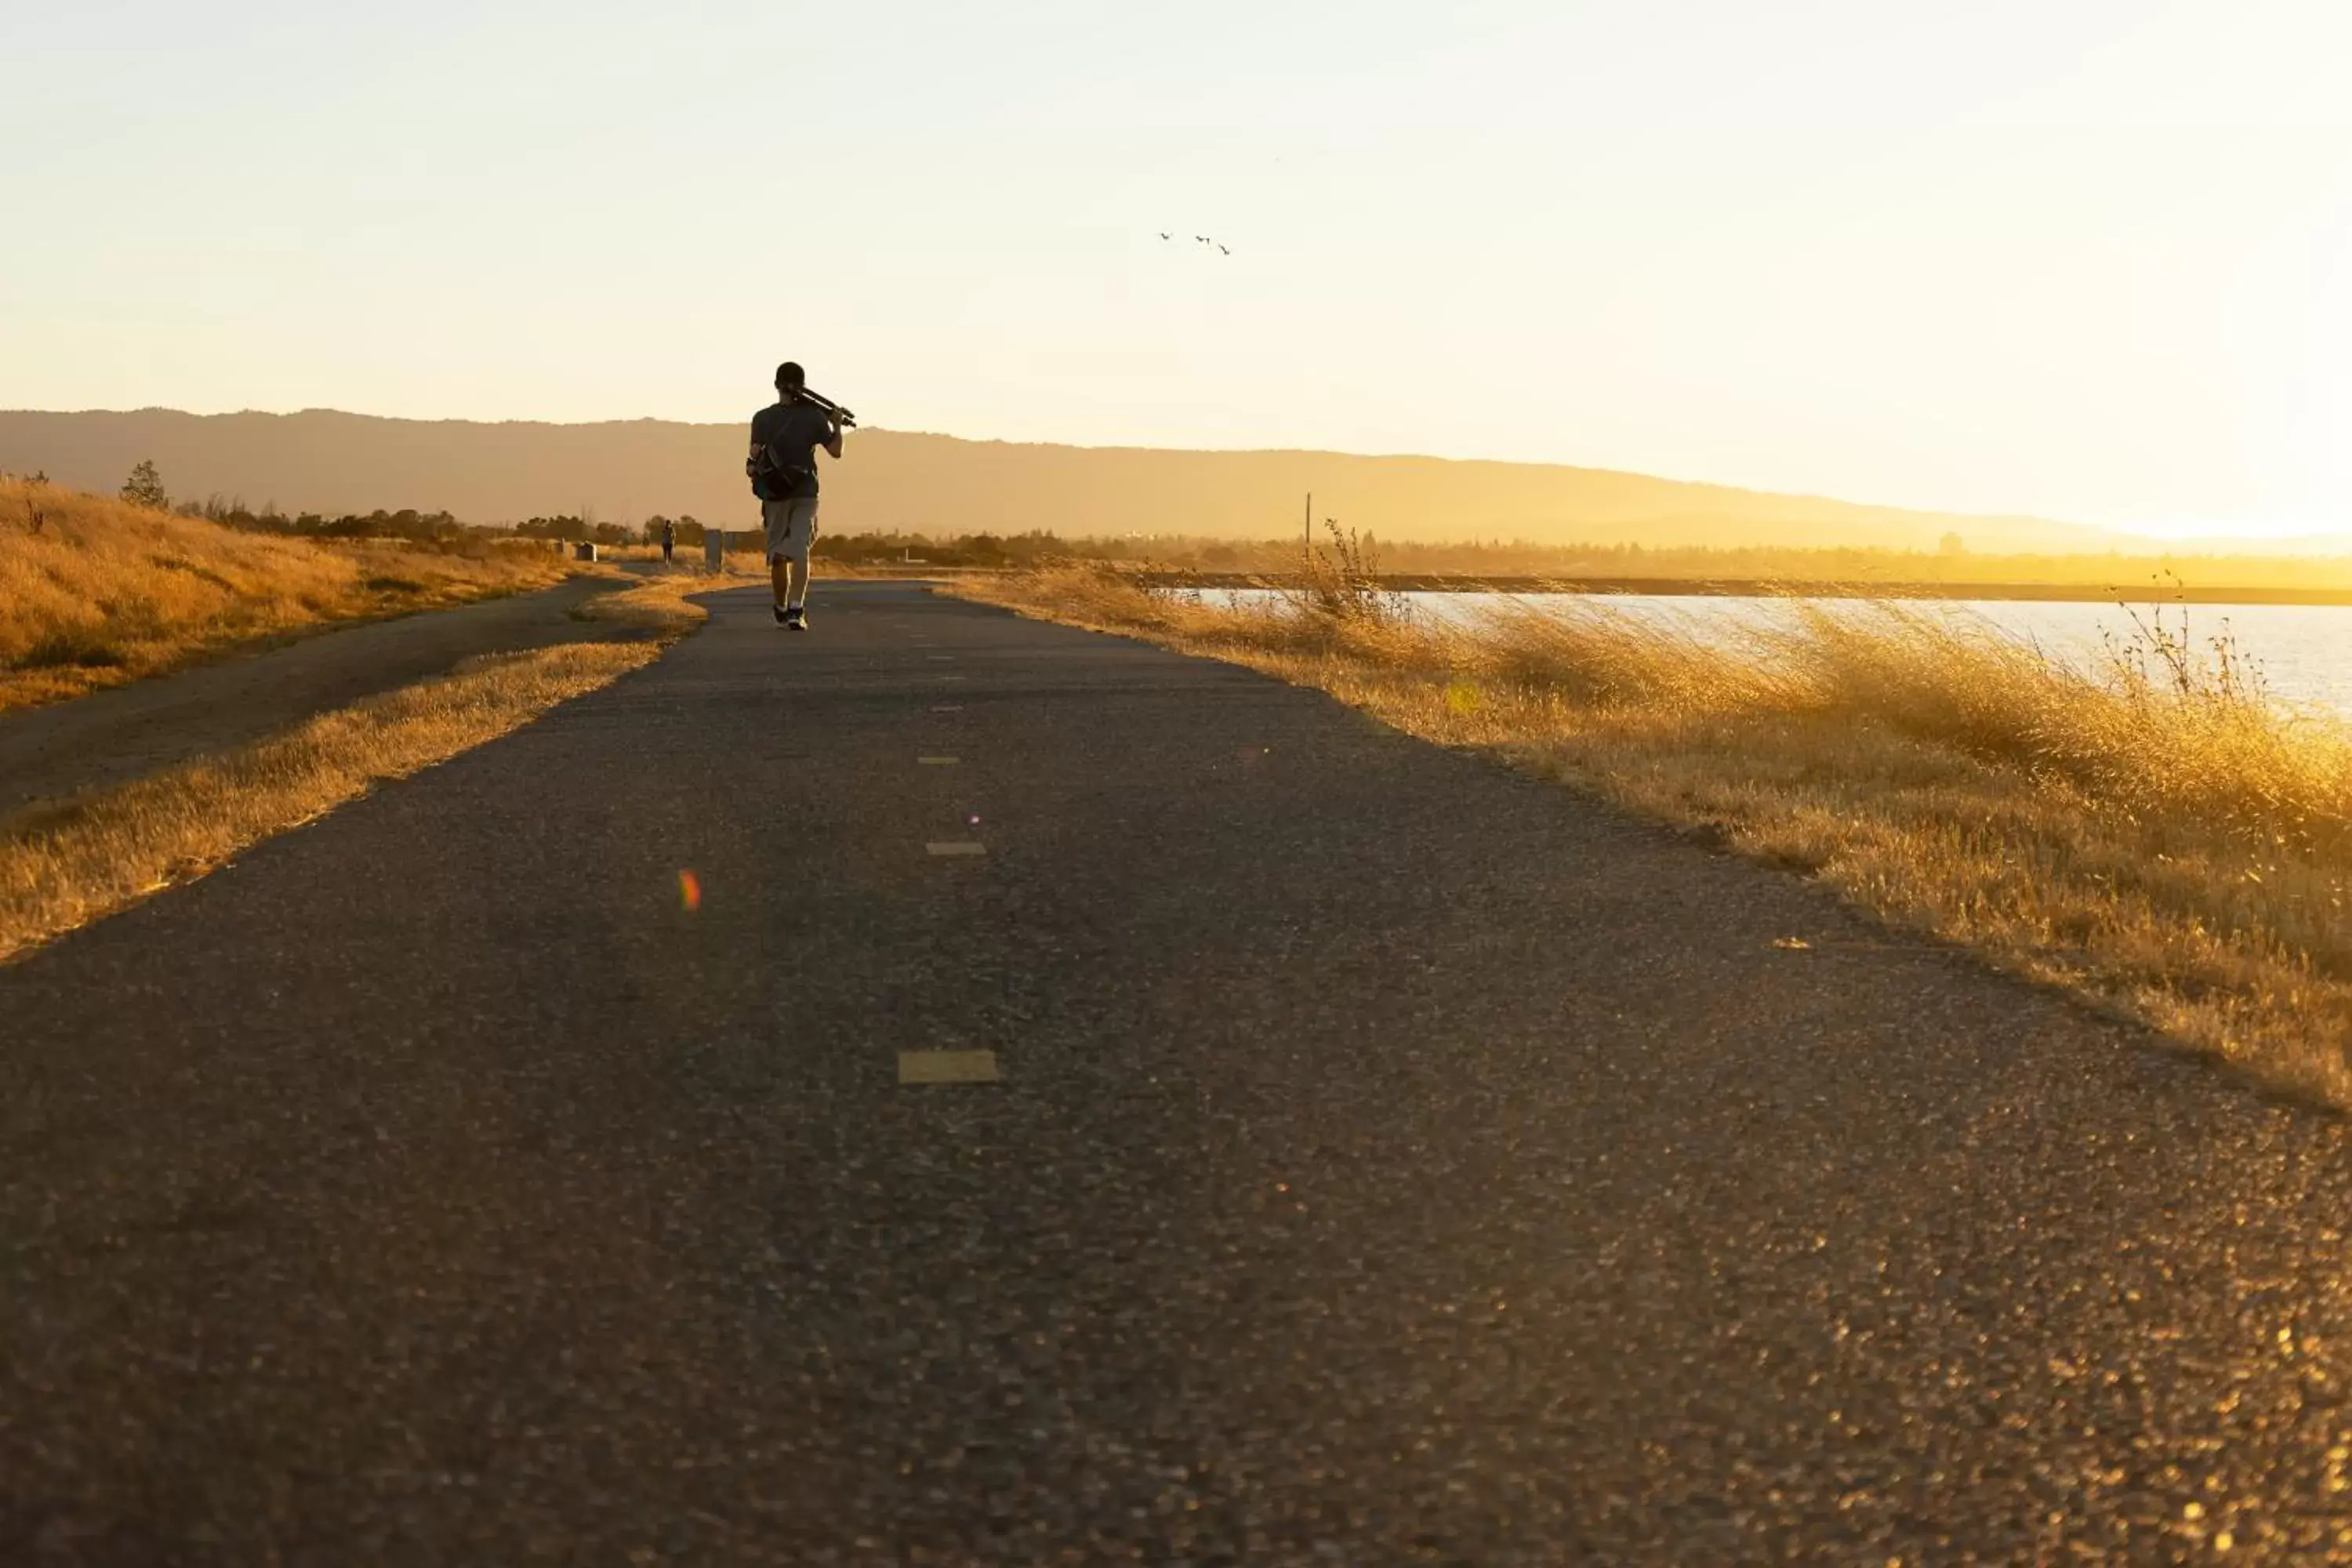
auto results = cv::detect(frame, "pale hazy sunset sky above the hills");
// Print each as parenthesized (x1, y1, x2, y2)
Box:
(0, 0, 2352, 532)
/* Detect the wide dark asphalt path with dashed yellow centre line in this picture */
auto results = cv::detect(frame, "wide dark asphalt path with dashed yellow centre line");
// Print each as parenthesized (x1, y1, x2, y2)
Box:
(0, 583, 2352, 1563)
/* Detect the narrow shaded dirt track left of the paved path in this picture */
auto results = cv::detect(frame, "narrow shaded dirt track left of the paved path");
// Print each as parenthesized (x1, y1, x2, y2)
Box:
(0, 576, 626, 815)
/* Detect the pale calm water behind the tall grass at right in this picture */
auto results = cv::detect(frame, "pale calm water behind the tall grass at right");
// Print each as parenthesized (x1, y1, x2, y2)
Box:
(1230, 590, 2352, 715)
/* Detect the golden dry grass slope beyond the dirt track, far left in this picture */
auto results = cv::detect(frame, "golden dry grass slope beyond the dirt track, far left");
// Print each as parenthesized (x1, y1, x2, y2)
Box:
(0, 480, 567, 710)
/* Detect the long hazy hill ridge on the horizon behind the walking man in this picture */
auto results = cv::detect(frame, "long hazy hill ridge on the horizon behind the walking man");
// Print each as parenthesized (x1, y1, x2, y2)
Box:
(0, 409, 2140, 550)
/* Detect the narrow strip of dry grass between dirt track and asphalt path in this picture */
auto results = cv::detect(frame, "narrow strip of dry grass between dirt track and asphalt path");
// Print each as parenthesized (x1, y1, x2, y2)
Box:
(0, 576, 713, 961)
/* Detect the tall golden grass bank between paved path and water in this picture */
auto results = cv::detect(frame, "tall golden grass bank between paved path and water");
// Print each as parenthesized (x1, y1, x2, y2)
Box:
(955, 557, 2352, 1107)
